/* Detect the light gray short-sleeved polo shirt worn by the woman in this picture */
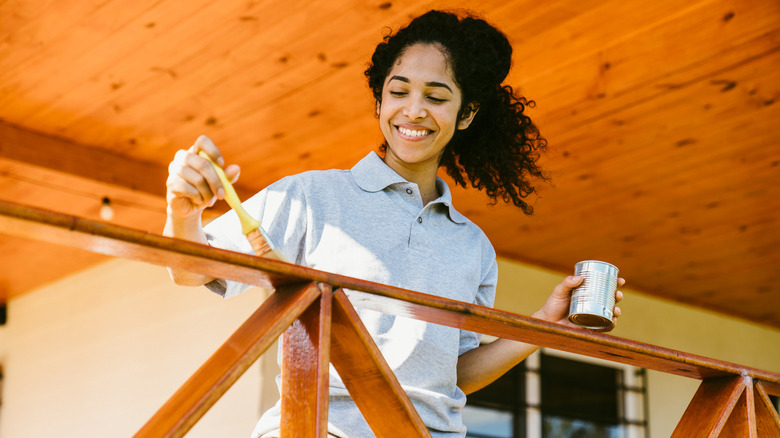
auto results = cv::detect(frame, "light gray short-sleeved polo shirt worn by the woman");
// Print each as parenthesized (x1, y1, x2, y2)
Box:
(206, 152, 498, 438)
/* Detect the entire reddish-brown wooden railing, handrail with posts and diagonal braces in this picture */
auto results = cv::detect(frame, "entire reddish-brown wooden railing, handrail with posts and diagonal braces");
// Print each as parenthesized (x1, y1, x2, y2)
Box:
(0, 202, 780, 438)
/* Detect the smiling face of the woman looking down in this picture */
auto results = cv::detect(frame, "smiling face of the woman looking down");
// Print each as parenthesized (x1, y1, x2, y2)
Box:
(378, 44, 473, 183)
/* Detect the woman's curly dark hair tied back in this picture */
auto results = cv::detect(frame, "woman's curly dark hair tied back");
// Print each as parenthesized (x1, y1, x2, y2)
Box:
(365, 10, 548, 215)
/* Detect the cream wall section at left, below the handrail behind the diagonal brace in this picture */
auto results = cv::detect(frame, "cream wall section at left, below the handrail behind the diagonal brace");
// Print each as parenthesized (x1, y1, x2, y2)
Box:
(0, 260, 278, 438)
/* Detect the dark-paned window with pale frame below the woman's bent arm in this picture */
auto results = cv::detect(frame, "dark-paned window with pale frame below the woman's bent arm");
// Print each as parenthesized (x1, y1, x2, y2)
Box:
(463, 349, 648, 438)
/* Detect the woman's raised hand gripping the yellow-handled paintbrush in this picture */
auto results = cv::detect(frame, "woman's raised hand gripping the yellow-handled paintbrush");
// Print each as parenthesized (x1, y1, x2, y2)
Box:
(166, 135, 240, 220)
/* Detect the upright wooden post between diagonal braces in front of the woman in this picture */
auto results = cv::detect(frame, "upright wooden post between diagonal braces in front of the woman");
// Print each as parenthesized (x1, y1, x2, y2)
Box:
(280, 285, 331, 438)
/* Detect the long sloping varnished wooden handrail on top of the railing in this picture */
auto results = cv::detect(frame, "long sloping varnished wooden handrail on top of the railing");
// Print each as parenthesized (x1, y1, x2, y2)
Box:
(0, 202, 780, 388)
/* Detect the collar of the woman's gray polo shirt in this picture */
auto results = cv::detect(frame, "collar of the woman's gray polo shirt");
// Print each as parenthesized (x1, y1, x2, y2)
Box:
(351, 151, 468, 224)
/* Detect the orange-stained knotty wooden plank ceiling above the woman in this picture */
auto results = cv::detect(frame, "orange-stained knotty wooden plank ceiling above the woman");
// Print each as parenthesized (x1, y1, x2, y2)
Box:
(0, 0, 780, 328)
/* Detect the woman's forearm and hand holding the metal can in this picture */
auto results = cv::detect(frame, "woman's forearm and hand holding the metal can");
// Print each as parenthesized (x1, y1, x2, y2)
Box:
(458, 276, 625, 394)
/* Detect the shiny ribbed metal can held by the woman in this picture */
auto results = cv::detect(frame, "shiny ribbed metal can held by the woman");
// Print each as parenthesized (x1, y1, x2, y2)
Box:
(569, 260, 618, 330)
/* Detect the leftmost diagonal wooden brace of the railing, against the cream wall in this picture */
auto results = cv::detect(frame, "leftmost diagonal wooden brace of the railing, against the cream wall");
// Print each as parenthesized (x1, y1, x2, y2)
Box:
(135, 283, 320, 438)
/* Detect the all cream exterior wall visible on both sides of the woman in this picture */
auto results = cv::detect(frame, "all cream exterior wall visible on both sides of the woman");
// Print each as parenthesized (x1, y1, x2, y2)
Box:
(0, 260, 780, 438)
